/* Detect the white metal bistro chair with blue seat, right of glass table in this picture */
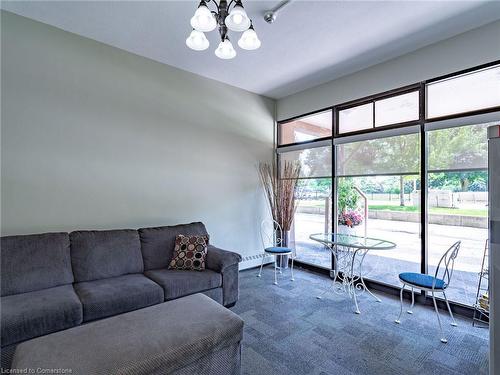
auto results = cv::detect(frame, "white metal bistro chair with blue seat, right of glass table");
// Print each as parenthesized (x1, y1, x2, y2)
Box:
(395, 241, 460, 344)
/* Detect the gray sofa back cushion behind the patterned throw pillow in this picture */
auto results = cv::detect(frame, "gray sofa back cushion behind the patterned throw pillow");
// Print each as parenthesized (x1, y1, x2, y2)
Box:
(139, 222, 208, 271)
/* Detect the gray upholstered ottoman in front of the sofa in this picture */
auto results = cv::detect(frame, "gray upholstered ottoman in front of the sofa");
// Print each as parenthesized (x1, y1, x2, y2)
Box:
(12, 294, 243, 375)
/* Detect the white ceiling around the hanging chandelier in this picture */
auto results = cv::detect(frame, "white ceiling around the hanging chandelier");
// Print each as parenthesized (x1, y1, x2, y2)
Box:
(1, 0, 500, 98)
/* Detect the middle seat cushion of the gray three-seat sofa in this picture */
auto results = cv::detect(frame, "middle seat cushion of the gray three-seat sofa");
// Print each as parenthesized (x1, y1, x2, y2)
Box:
(75, 274, 163, 322)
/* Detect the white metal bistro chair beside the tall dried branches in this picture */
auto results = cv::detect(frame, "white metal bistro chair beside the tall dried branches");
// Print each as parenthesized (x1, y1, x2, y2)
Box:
(257, 220, 295, 285)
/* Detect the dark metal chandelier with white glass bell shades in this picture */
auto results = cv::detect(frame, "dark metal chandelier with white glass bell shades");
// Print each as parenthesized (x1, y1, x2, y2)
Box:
(186, 0, 260, 59)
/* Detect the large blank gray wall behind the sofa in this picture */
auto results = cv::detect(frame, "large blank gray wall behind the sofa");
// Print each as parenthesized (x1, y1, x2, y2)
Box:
(1, 12, 275, 266)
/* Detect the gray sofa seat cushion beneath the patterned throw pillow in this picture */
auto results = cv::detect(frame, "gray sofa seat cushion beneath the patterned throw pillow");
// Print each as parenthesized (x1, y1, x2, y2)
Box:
(145, 269, 222, 301)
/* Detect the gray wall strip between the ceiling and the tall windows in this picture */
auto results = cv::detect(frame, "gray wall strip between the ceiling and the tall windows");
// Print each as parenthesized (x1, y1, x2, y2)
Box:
(277, 21, 500, 120)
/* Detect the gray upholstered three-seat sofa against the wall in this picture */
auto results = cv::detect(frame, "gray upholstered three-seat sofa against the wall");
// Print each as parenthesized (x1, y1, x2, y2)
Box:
(1, 223, 241, 368)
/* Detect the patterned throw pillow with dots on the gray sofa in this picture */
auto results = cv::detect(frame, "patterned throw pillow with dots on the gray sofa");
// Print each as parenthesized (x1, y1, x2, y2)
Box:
(168, 234, 208, 271)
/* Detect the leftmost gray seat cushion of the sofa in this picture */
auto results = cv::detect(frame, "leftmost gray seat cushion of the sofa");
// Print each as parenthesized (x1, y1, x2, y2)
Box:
(1, 285, 82, 346)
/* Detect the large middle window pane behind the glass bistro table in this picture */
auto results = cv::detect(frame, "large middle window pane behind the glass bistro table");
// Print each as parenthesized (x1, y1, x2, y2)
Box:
(336, 133, 421, 286)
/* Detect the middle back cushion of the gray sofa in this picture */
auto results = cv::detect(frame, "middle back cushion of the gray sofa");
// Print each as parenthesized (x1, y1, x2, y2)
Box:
(69, 229, 144, 282)
